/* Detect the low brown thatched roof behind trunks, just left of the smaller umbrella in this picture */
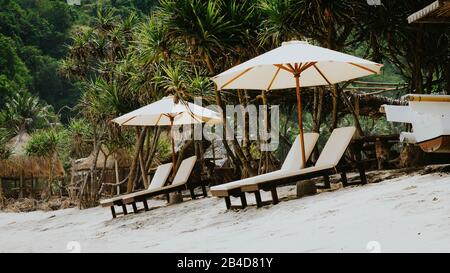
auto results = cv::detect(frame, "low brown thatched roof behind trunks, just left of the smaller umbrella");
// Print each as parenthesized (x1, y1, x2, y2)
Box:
(72, 148, 132, 172)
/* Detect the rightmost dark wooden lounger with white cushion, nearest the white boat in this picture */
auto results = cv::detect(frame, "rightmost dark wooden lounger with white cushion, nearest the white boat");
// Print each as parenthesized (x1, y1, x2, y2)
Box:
(241, 127, 367, 207)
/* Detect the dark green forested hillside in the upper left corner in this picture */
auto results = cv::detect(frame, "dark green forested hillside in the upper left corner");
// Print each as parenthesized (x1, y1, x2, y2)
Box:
(0, 0, 78, 119)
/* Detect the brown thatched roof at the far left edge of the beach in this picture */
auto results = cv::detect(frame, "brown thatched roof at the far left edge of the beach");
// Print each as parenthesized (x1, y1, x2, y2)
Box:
(0, 132, 65, 179)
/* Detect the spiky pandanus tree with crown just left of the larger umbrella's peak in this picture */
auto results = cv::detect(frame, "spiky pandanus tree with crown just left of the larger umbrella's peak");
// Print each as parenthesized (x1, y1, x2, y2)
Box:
(158, 0, 264, 175)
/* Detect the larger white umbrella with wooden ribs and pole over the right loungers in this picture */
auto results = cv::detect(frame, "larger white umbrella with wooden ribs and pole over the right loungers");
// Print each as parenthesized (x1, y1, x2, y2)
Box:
(212, 41, 383, 167)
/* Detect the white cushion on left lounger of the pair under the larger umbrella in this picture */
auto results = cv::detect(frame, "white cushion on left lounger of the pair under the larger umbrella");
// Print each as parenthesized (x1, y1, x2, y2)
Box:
(210, 133, 319, 191)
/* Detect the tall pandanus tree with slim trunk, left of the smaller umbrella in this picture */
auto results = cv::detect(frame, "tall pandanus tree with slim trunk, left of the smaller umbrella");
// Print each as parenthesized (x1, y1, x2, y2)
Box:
(63, 9, 146, 206)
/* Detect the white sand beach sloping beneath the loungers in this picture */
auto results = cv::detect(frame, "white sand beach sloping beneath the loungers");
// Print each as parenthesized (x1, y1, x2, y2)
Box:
(0, 171, 450, 252)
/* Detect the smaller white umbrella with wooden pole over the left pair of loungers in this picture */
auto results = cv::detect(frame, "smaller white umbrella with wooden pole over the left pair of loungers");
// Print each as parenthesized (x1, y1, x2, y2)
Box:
(112, 96, 222, 165)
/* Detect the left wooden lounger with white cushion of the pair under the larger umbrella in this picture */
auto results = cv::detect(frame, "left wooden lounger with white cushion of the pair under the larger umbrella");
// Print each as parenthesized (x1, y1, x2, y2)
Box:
(210, 133, 319, 209)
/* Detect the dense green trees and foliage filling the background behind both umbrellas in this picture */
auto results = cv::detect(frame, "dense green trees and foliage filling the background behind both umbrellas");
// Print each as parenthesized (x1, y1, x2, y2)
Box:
(0, 0, 450, 204)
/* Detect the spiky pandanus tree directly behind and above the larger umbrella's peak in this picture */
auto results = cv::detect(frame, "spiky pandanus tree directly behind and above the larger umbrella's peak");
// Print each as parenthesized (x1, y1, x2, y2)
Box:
(259, 0, 368, 133)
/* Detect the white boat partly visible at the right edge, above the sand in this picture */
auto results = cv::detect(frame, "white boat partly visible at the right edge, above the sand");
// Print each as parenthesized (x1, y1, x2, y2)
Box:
(382, 94, 450, 153)
